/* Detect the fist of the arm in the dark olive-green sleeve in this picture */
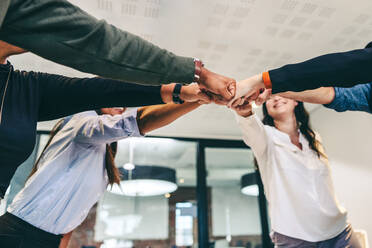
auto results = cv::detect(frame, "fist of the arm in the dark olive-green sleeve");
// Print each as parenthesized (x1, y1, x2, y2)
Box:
(198, 67, 236, 103)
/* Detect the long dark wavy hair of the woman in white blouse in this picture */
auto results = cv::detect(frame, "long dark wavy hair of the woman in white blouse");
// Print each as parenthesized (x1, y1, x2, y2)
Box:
(262, 102, 326, 157)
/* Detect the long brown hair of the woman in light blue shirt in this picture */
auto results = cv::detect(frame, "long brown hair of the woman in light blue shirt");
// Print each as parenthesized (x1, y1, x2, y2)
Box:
(28, 110, 120, 186)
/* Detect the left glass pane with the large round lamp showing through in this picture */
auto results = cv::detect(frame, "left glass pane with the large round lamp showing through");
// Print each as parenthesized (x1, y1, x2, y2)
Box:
(95, 138, 201, 248)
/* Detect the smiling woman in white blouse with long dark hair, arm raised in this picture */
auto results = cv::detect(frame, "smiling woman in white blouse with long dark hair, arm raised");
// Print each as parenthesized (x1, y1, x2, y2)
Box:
(234, 96, 359, 248)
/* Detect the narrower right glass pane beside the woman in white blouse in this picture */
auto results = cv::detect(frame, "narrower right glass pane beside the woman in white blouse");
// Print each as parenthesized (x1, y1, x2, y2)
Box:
(205, 148, 262, 248)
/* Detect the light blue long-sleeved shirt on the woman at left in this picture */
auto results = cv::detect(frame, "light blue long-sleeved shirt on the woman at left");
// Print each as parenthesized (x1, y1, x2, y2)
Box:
(8, 111, 141, 234)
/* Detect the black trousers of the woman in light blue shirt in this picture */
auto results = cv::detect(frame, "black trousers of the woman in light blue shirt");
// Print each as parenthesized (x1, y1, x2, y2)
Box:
(0, 213, 62, 248)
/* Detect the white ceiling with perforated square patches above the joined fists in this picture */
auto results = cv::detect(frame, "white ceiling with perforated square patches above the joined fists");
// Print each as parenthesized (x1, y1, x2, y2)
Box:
(11, 0, 372, 138)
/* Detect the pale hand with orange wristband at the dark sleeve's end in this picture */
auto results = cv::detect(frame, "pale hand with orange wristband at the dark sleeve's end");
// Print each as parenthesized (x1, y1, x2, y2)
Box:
(228, 74, 265, 107)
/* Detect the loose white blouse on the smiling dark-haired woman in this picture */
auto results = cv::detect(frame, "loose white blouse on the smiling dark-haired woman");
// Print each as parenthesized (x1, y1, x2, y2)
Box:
(237, 115, 347, 242)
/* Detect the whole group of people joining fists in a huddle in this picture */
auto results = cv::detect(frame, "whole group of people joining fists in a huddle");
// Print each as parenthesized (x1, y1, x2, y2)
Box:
(0, 0, 372, 248)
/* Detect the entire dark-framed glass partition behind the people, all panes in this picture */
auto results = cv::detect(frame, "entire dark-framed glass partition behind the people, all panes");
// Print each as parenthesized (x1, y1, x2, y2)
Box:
(2, 132, 269, 248)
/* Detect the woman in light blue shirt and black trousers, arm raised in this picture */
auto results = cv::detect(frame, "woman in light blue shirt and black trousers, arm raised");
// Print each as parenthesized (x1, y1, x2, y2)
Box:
(0, 98, 200, 248)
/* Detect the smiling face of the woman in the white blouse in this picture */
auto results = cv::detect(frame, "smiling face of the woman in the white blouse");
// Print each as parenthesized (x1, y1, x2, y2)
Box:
(266, 96, 298, 120)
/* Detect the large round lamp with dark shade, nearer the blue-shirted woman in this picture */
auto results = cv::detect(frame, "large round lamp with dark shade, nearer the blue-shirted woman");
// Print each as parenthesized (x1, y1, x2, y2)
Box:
(108, 165, 178, 196)
